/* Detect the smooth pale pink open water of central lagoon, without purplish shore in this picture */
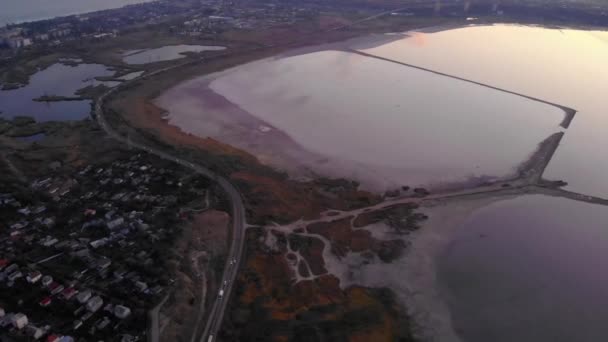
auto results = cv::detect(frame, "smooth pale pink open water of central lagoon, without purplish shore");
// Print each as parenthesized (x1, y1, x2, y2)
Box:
(205, 51, 564, 191)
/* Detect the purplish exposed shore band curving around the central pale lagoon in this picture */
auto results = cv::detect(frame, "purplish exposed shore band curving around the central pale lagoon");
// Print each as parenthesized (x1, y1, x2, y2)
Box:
(153, 25, 574, 193)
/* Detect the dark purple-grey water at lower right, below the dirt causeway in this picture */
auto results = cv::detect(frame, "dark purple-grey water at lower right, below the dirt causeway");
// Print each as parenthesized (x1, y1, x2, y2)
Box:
(438, 195, 608, 342)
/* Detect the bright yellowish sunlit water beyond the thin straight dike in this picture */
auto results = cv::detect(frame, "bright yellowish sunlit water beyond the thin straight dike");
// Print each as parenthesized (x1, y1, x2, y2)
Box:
(355, 25, 608, 197)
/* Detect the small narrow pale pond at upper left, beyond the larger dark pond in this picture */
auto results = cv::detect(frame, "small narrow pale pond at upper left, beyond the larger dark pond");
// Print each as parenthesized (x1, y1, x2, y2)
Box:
(123, 45, 226, 64)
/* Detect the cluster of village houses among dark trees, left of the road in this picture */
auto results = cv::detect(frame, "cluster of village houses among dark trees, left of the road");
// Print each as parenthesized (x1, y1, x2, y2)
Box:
(0, 154, 213, 341)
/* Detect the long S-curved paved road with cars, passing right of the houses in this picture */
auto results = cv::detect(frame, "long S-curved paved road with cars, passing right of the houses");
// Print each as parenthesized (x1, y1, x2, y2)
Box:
(94, 69, 246, 342)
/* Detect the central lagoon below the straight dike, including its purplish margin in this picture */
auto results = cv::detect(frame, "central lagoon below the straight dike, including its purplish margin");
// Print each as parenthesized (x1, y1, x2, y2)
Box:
(158, 35, 564, 190)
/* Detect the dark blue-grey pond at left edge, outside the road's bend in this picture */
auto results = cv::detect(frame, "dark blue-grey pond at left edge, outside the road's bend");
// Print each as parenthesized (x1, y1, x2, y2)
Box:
(0, 64, 115, 121)
